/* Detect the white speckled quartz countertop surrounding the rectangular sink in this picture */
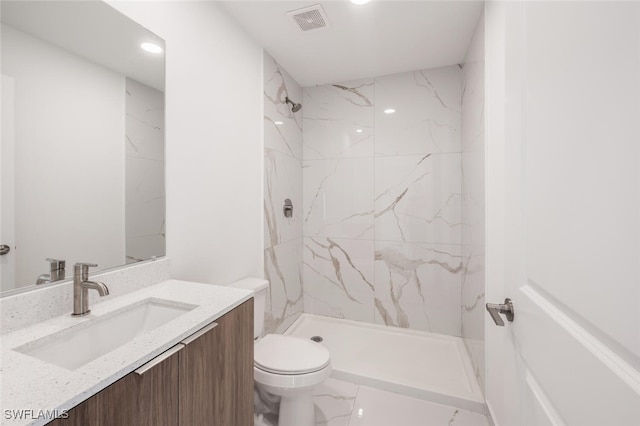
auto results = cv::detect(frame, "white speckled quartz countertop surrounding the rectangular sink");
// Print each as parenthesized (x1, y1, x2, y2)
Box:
(0, 280, 252, 425)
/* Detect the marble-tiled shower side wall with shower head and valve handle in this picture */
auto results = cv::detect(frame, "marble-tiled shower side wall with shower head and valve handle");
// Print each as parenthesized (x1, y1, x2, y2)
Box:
(264, 52, 303, 333)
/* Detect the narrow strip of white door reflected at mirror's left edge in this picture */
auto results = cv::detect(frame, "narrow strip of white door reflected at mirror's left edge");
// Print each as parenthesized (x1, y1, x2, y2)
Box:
(0, 75, 15, 291)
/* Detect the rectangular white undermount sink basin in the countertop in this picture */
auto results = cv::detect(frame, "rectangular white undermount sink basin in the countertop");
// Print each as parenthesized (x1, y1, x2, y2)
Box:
(14, 299, 196, 370)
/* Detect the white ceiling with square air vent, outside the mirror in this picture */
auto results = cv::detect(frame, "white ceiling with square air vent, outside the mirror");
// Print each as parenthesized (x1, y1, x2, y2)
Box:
(220, 0, 484, 87)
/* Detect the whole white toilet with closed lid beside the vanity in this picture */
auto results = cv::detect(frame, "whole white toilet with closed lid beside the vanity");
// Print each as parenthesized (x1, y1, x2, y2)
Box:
(231, 278, 331, 426)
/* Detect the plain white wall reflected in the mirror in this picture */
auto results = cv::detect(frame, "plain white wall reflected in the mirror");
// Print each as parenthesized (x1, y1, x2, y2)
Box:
(2, 25, 125, 285)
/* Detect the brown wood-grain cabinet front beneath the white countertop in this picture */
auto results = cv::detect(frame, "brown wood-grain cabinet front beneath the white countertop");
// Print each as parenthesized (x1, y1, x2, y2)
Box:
(49, 299, 253, 426)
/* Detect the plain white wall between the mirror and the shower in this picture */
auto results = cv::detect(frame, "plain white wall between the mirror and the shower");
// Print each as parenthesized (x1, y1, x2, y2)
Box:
(109, 1, 263, 284)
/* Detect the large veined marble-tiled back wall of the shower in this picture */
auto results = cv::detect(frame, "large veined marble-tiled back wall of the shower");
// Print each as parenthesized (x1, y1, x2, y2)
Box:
(301, 65, 464, 335)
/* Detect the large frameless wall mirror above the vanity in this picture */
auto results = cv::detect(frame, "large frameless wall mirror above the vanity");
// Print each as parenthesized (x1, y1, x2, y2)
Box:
(0, 0, 165, 295)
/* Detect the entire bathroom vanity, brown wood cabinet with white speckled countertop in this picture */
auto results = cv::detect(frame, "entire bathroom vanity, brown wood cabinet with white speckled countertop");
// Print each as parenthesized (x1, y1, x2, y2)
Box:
(0, 280, 254, 426)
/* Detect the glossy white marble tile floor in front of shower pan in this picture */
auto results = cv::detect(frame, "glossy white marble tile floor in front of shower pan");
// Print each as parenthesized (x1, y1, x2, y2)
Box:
(256, 379, 488, 426)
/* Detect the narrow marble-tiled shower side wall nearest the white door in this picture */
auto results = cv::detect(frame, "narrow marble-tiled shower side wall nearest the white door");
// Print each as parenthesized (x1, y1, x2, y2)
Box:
(461, 15, 485, 388)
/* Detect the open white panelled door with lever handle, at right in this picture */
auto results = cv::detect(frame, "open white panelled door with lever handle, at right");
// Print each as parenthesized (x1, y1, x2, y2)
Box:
(486, 1, 640, 426)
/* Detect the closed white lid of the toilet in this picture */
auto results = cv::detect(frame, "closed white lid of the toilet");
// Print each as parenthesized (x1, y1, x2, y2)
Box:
(254, 334, 330, 374)
